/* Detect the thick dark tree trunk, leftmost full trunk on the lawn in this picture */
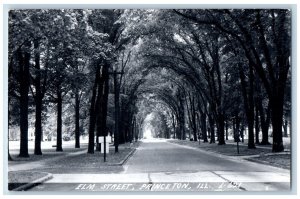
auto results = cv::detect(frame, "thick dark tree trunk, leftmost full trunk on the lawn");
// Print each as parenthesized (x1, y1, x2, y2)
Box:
(18, 41, 31, 157)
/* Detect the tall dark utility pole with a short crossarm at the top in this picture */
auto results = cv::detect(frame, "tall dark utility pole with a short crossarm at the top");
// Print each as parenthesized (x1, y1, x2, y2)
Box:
(109, 70, 124, 153)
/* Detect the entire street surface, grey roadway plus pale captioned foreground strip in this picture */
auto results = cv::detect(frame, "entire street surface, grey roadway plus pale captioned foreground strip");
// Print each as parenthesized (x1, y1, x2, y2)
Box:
(27, 140, 290, 191)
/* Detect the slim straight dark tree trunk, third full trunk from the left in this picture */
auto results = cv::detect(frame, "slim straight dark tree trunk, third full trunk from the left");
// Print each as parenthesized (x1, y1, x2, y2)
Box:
(56, 88, 63, 151)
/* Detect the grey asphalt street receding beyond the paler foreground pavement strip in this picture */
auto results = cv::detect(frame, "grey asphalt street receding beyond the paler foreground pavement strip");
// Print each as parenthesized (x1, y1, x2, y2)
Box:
(125, 140, 273, 173)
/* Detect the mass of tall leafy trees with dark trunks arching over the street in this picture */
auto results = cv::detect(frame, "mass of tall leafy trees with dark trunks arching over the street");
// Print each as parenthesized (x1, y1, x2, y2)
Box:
(8, 9, 291, 157)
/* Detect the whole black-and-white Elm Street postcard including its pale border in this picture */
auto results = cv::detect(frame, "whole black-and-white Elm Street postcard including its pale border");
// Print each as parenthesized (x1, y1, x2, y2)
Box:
(4, 1, 296, 195)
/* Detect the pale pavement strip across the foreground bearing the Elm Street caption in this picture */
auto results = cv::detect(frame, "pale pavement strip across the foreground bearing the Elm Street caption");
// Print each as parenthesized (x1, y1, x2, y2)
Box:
(30, 171, 290, 193)
